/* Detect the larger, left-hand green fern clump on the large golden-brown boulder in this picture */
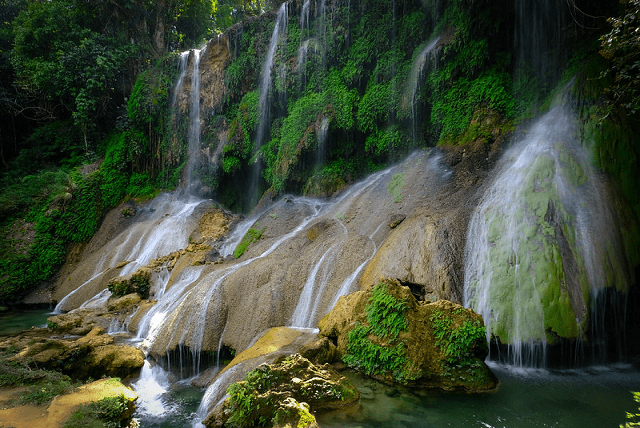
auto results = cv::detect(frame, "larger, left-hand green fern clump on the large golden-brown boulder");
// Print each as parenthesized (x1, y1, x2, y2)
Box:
(342, 283, 414, 383)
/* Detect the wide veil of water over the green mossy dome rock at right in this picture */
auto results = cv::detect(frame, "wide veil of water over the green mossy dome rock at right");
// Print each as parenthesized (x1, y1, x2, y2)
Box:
(465, 106, 628, 366)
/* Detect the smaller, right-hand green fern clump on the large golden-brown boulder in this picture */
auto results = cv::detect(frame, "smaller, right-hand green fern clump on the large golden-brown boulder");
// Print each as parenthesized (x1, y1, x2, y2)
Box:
(429, 310, 486, 366)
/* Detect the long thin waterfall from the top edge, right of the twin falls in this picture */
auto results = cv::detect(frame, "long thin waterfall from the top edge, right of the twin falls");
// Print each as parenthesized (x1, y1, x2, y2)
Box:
(248, 2, 288, 205)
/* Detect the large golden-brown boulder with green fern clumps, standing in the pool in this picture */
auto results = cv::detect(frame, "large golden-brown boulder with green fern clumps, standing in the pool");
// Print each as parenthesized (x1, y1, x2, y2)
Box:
(320, 280, 496, 391)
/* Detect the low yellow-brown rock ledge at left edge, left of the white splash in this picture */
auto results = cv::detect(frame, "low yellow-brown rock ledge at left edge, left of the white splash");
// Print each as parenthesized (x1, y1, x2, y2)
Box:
(0, 327, 144, 379)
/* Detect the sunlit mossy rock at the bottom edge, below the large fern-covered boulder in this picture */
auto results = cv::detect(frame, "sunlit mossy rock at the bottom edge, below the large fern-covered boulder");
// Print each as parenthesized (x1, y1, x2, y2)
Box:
(204, 354, 360, 427)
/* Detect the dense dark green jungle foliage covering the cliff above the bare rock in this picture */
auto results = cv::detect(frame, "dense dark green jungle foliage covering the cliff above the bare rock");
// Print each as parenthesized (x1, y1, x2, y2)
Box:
(0, 0, 640, 303)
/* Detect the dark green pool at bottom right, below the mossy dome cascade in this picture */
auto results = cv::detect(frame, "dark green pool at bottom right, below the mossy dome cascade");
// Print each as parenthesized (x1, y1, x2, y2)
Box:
(317, 363, 640, 428)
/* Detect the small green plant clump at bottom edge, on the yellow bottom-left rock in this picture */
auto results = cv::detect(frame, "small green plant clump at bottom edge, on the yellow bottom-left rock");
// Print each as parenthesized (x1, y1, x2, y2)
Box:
(62, 395, 128, 428)
